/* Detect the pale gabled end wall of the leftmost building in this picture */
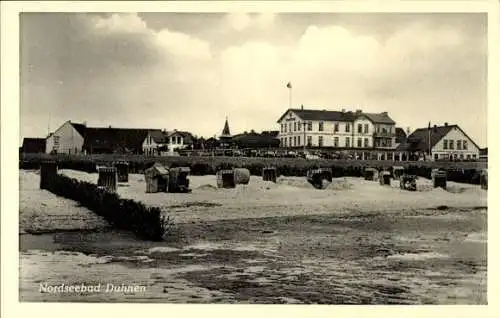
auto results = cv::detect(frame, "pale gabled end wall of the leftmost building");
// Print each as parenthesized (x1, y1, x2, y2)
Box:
(45, 120, 86, 154)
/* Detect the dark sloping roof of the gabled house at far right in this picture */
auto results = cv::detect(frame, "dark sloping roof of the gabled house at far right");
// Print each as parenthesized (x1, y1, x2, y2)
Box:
(406, 125, 479, 151)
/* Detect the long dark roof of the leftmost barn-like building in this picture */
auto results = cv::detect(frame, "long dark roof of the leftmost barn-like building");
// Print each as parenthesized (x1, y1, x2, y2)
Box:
(83, 127, 154, 152)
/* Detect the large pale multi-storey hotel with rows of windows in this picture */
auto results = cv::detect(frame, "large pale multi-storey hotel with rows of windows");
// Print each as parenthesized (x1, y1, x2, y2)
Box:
(277, 107, 396, 149)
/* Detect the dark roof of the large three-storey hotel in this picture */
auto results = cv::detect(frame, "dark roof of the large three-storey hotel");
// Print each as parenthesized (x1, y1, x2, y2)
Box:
(278, 108, 395, 124)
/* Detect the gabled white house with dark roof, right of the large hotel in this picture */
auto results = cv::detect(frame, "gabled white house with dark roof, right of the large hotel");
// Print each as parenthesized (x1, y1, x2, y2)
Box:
(401, 123, 479, 160)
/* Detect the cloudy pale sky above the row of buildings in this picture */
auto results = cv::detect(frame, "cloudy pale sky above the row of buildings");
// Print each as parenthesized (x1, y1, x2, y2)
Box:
(20, 13, 487, 147)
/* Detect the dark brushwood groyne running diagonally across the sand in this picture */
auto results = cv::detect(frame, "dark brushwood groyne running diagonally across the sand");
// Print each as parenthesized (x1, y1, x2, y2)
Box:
(43, 175, 171, 241)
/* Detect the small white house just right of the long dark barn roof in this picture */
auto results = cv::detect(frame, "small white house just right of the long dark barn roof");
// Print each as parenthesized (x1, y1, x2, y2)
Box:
(142, 129, 193, 156)
